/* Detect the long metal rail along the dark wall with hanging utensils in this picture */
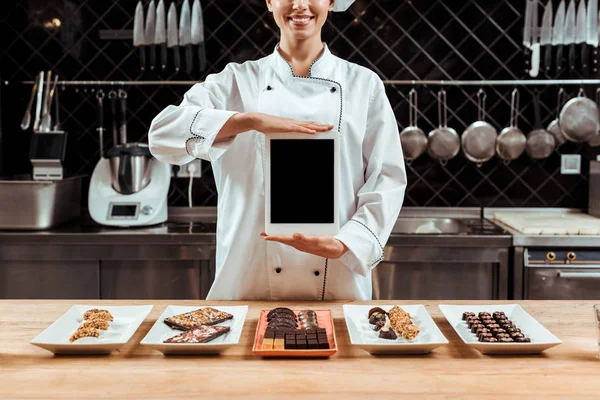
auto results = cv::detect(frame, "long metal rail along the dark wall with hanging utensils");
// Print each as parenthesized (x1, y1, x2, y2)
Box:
(4, 79, 600, 86)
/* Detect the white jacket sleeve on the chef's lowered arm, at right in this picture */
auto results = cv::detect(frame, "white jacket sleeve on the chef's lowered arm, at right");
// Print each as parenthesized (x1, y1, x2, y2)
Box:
(336, 80, 406, 276)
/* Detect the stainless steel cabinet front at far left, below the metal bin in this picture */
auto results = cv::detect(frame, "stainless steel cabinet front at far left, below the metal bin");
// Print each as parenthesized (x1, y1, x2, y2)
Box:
(0, 261, 100, 299)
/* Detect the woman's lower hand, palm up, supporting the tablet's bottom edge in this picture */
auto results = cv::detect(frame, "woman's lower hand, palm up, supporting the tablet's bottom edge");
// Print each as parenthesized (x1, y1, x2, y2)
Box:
(260, 232, 348, 260)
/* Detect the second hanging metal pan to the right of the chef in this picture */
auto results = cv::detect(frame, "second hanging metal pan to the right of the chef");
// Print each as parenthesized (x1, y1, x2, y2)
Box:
(427, 89, 460, 164)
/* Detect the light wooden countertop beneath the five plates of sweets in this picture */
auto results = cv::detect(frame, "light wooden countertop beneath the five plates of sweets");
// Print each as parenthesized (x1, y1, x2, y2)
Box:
(0, 300, 600, 400)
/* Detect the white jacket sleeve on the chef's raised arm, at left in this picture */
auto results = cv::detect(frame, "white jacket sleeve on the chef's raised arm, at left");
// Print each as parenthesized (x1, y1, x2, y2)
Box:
(148, 64, 241, 165)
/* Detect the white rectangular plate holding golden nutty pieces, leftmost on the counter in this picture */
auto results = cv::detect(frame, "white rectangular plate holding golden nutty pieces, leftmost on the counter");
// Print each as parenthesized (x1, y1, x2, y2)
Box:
(29, 305, 154, 354)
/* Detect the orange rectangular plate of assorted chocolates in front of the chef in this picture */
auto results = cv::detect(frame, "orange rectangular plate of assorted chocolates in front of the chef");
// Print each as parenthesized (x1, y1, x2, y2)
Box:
(252, 310, 337, 357)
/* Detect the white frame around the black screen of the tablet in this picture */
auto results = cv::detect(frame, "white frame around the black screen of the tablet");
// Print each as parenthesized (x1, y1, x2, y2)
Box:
(265, 131, 340, 236)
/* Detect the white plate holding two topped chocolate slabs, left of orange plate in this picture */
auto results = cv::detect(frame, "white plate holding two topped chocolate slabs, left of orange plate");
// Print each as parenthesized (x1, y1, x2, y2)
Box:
(140, 306, 248, 354)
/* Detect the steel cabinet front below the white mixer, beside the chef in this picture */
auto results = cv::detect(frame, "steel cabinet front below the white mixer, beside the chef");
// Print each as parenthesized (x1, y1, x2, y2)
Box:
(100, 260, 214, 299)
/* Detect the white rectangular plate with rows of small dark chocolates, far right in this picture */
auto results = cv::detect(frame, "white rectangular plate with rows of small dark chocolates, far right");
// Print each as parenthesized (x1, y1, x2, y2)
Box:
(439, 304, 562, 354)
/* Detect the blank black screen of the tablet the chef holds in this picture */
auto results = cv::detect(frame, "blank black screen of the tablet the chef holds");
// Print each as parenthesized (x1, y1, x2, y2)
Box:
(271, 139, 334, 224)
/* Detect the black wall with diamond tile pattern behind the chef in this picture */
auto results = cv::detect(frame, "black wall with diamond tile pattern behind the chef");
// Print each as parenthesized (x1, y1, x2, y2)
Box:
(0, 0, 597, 207)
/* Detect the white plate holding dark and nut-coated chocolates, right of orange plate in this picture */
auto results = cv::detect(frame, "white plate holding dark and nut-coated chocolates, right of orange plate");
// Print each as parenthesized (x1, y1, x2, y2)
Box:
(343, 304, 448, 354)
